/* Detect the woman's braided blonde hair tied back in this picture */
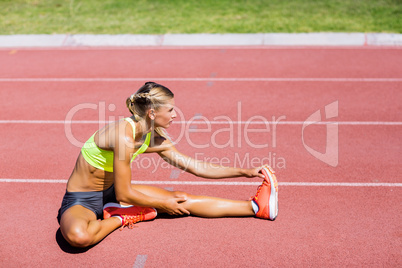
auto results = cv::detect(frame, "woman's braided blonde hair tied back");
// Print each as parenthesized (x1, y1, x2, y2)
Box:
(126, 82, 174, 138)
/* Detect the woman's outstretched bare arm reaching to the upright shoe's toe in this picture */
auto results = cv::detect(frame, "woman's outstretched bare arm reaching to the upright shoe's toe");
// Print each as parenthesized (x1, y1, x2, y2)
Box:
(158, 140, 264, 179)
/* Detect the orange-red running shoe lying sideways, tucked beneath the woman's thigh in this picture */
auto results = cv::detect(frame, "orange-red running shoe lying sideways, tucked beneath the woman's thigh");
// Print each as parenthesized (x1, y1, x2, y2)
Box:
(103, 203, 157, 229)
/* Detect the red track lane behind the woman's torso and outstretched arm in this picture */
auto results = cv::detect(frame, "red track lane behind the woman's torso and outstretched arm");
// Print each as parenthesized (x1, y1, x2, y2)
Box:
(0, 124, 402, 183)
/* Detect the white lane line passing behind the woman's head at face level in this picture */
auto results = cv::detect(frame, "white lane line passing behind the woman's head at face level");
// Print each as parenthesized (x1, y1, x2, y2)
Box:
(0, 120, 402, 126)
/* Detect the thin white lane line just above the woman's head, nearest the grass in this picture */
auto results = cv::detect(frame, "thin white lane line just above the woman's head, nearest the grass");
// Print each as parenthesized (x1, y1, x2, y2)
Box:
(0, 77, 402, 82)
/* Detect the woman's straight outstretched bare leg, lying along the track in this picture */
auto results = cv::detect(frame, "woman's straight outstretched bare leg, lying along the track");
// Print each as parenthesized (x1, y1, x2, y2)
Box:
(132, 185, 255, 218)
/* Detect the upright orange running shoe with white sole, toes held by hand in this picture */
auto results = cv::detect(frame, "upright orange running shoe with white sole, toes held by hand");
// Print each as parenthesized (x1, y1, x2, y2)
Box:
(252, 166, 278, 221)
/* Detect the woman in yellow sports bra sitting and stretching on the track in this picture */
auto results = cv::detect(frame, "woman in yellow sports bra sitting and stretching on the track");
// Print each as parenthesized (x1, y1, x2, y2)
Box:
(58, 82, 278, 247)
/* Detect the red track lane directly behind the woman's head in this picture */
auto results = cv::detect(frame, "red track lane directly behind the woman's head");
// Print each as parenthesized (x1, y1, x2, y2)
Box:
(0, 82, 402, 122)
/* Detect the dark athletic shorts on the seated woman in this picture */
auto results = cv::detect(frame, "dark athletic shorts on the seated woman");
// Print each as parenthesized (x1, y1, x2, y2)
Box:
(57, 185, 117, 224)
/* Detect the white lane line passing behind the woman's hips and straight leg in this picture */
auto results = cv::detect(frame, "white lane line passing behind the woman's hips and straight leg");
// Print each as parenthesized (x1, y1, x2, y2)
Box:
(0, 178, 402, 187)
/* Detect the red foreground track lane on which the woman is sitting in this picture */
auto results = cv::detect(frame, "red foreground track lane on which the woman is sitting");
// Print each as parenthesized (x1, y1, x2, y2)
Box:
(0, 184, 402, 267)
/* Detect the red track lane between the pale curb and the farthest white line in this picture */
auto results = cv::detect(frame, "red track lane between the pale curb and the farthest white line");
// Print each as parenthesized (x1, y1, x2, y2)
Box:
(0, 47, 402, 78)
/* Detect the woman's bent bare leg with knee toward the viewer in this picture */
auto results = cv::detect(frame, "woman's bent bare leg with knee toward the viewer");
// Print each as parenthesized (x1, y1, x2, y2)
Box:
(60, 205, 121, 247)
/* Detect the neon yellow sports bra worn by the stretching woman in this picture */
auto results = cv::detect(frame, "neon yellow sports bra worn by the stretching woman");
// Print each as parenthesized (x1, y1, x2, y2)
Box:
(81, 117, 151, 172)
